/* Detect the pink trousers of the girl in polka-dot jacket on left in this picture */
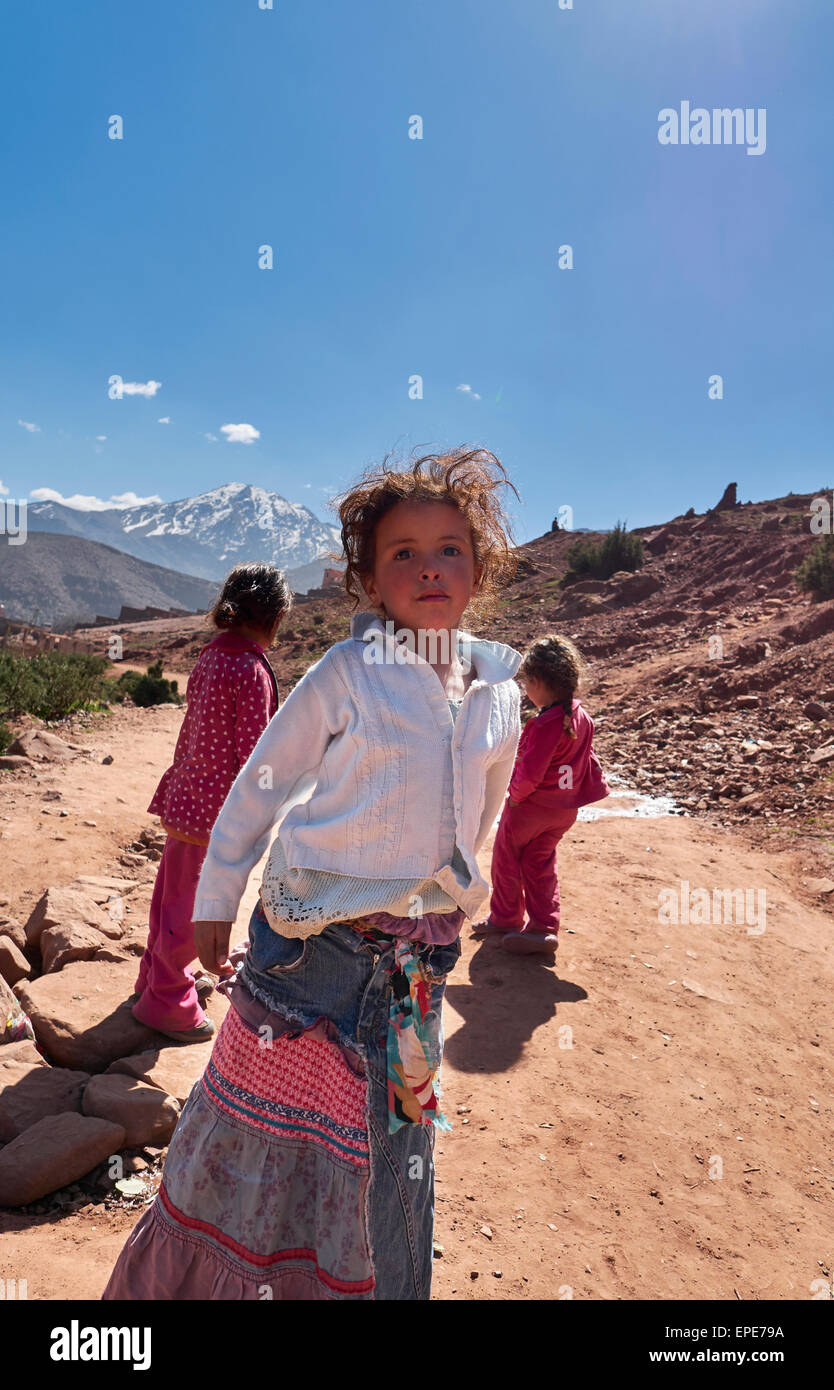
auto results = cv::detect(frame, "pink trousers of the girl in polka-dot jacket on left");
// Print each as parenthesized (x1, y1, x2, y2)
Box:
(132, 835, 209, 1030)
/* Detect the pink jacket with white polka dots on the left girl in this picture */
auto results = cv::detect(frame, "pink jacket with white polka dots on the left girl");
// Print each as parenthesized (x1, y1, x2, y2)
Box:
(147, 631, 278, 845)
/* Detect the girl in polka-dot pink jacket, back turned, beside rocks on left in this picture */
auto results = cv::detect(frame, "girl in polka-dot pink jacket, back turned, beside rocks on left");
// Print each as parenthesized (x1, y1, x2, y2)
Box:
(132, 564, 292, 1043)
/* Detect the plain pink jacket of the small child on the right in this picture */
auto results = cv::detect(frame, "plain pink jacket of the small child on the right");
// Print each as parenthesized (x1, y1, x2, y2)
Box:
(509, 699, 610, 810)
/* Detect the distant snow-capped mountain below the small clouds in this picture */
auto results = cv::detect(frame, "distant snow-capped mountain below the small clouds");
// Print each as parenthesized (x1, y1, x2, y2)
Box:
(28, 482, 342, 592)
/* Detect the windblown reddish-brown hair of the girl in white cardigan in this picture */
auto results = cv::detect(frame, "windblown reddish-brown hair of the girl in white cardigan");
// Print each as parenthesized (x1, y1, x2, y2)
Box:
(329, 445, 518, 620)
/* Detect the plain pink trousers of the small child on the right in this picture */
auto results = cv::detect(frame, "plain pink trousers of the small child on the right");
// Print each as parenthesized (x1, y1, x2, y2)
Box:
(489, 801, 578, 934)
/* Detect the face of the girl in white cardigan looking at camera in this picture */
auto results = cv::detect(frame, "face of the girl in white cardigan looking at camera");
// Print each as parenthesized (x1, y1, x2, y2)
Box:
(366, 502, 482, 632)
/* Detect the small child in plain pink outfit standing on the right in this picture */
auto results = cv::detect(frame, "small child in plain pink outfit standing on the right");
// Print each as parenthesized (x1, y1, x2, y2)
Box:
(474, 637, 610, 955)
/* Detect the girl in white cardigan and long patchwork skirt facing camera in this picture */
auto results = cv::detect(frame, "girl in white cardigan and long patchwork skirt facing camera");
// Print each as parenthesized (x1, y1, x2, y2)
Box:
(104, 449, 520, 1300)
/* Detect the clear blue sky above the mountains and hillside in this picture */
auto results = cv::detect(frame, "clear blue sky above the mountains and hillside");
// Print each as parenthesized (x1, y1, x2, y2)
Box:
(0, 0, 834, 541)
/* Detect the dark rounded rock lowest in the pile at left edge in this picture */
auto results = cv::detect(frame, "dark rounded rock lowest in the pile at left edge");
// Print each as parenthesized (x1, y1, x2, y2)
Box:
(0, 1111, 125, 1207)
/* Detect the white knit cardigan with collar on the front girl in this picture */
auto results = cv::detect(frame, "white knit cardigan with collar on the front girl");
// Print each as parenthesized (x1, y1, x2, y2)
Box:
(193, 612, 521, 927)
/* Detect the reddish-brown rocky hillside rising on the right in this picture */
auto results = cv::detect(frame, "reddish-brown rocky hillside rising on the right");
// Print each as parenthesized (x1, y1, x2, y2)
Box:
(493, 493, 834, 838)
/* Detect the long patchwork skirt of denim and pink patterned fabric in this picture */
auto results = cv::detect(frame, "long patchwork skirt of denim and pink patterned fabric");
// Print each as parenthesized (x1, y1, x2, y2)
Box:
(103, 904, 461, 1300)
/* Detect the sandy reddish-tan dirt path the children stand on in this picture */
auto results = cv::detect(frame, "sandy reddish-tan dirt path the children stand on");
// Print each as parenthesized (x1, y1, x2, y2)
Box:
(0, 706, 834, 1300)
